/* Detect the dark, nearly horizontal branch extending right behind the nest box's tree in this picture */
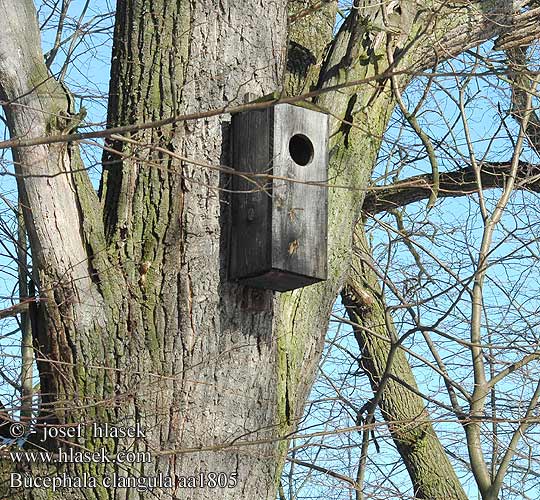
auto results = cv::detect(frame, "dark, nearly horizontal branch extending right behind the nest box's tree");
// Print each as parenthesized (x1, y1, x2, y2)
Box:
(363, 162, 540, 215)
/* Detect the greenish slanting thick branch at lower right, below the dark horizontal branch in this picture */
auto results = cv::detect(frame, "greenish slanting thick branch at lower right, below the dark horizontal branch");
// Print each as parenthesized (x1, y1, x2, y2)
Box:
(342, 224, 466, 500)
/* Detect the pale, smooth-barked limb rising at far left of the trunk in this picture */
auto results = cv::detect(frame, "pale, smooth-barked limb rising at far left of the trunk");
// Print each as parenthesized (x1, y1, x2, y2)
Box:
(0, 0, 103, 286)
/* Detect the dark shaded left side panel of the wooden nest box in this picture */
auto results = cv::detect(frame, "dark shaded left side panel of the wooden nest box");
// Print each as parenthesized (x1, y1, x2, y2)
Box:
(229, 109, 272, 279)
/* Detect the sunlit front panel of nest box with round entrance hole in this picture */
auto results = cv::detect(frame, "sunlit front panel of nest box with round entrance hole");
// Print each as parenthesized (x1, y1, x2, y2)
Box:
(272, 104, 328, 286)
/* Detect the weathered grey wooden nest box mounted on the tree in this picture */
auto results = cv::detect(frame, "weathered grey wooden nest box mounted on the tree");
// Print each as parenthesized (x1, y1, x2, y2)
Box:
(229, 104, 328, 292)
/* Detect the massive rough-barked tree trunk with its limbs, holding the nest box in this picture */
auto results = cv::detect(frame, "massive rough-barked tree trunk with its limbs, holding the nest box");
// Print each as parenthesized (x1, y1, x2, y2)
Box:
(0, 0, 536, 500)
